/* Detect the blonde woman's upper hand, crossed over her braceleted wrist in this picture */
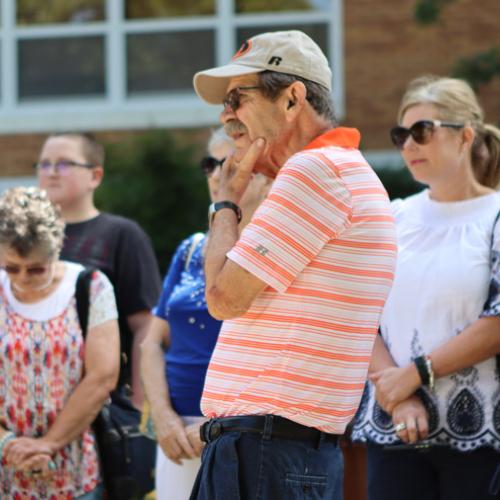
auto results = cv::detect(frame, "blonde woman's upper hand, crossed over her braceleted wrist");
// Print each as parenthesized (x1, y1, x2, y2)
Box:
(369, 363, 422, 414)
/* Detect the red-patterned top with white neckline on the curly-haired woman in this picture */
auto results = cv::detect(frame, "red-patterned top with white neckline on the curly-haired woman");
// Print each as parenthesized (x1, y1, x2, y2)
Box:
(0, 262, 117, 500)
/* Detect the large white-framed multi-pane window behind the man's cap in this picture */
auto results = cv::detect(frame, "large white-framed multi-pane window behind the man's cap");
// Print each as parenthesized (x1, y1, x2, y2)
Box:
(0, 0, 344, 133)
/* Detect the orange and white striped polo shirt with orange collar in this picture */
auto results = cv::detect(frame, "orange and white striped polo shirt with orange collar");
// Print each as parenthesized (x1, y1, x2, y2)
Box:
(201, 127, 396, 434)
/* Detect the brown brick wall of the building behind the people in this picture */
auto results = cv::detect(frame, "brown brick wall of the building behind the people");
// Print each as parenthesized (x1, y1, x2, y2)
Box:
(0, 0, 500, 176)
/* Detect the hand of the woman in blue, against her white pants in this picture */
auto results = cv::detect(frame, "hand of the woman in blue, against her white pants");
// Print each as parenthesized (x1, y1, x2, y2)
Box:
(155, 414, 199, 465)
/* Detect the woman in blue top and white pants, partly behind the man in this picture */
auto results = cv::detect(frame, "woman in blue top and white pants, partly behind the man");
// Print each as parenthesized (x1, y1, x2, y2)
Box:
(141, 129, 270, 500)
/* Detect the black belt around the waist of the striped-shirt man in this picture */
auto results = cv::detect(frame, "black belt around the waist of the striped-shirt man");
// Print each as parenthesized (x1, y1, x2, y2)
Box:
(200, 415, 340, 444)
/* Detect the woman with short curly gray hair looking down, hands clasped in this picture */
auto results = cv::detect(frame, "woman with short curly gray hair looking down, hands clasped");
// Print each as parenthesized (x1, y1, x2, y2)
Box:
(0, 187, 119, 500)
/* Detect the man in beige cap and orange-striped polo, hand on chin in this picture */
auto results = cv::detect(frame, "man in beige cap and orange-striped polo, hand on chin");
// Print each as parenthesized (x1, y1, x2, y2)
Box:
(192, 31, 396, 500)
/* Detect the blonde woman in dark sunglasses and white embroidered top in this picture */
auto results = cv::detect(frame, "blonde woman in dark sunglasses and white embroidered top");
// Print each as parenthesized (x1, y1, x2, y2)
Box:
(353, 77, 500, 500)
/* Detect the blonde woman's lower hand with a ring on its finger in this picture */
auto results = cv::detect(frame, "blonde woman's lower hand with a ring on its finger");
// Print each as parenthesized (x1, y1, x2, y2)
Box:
(392, 395, 429, 443)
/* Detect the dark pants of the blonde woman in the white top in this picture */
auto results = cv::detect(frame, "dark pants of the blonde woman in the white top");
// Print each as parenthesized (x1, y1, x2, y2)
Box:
(367, 443, 500, 500)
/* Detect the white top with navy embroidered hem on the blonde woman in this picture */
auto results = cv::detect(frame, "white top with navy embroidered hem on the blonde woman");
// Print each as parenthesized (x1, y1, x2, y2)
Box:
(352, 190, 500, 451)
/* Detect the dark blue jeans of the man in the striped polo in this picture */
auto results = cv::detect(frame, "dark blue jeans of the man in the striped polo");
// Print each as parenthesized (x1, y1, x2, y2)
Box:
(190, 416, 344, 500)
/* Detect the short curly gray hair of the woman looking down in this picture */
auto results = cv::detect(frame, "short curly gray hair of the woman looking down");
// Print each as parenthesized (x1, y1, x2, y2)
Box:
(0, 187, 64, 258)
